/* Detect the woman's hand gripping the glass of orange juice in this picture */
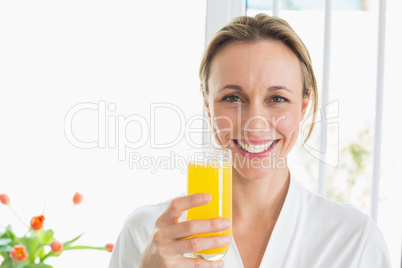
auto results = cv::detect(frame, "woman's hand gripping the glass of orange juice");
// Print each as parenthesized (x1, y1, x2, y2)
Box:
(139, 194, 231, 268)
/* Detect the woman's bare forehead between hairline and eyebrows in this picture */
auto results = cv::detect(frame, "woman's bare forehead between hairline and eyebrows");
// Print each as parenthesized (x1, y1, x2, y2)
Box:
(208, 40, 303, 93)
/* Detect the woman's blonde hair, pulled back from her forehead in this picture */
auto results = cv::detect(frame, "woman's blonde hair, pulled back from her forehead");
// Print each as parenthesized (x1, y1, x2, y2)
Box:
(199, 14, 318, 143)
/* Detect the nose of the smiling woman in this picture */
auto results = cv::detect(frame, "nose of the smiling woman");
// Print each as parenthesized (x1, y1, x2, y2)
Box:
(242, 102, 271, 137)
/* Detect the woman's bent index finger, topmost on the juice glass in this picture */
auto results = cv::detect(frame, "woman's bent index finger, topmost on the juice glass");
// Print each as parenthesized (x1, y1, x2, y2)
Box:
(158, 193, 211, 224)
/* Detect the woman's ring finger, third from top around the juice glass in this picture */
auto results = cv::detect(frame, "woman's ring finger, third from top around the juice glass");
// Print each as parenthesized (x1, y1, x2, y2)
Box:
(164, 235, 232, 255)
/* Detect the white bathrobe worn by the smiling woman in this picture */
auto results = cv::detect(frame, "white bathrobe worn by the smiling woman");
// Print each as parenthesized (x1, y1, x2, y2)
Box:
(109, 176, 391, 268)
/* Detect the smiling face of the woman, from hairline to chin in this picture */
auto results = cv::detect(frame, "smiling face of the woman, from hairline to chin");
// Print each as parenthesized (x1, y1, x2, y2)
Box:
(204, 40, 309, 179)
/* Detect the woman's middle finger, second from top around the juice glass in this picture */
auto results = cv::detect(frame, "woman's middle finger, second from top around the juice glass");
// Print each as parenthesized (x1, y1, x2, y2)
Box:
(163, 218, 231, 240)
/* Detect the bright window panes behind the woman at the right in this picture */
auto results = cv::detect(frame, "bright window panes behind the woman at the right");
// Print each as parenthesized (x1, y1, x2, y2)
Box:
(247, 0, 402, 267)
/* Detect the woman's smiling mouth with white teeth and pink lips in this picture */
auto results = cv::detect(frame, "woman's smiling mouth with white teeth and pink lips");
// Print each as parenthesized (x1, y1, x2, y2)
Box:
(233, 140, 279, 158)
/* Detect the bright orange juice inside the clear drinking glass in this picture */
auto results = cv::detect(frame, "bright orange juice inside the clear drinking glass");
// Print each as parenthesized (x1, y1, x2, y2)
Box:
(187, 162, 232, 259)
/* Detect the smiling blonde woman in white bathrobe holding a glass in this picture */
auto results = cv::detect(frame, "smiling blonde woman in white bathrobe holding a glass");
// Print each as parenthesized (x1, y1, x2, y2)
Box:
(110, 14, 390, 268)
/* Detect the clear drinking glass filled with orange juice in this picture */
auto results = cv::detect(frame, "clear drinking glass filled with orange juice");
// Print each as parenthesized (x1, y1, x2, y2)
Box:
(186, 148, 232, 260)
